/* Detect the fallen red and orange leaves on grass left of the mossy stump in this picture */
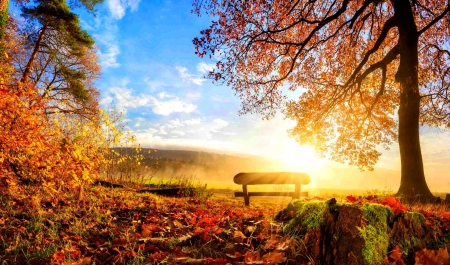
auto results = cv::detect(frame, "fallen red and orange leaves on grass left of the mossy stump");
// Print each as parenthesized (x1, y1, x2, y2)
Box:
(0, 187, 288, 264)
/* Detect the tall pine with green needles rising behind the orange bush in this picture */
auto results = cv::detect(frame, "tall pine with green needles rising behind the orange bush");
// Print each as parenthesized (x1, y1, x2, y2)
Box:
(16, 0, 100, 117)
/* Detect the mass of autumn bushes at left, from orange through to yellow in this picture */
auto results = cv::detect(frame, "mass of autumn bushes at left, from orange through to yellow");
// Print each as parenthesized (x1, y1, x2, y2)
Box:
(0, 80, 155, 199)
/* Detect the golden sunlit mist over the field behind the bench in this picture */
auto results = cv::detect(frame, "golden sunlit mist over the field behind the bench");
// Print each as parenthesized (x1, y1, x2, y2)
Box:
(114, 148, 450, 195)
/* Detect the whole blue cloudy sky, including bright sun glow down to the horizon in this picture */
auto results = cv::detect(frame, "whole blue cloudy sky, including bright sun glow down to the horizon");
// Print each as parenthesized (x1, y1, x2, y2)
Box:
(12, 0, 450, 191)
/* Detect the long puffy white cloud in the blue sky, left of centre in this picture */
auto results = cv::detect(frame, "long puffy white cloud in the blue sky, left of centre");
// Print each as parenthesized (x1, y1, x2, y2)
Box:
(107, 87, 197, 116)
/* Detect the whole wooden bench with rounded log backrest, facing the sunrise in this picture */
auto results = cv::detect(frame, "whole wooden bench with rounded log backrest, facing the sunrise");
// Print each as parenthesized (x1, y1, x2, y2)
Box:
(234, 172, 311, 206)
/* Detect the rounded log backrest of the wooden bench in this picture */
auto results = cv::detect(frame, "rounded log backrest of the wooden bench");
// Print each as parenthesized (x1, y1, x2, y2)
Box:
(234, 172, 311, 185)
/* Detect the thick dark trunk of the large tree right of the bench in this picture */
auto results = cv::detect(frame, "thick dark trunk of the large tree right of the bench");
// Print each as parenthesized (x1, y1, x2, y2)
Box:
(392, 0, 433, 199)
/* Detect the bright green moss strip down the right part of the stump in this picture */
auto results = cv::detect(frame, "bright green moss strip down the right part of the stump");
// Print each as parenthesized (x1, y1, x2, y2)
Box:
(358, 203, 393, 265)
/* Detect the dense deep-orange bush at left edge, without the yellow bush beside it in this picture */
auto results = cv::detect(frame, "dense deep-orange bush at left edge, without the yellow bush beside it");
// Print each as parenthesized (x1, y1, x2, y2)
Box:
(0, 81, 102, 197)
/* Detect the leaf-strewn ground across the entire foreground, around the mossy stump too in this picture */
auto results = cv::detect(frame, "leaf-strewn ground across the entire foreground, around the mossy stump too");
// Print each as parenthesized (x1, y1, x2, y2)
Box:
(0, 186, 450, 265)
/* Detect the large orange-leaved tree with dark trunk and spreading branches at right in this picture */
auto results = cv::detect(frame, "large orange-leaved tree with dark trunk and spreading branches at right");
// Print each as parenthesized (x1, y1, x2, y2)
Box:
(194, 0, 450, 198)
